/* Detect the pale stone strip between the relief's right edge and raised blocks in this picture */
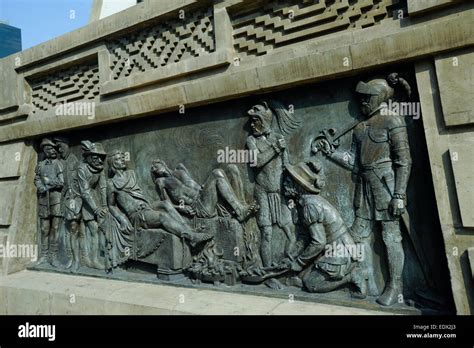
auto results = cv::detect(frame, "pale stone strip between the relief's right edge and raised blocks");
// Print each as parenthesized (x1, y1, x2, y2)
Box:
(415, 61, 474, 314)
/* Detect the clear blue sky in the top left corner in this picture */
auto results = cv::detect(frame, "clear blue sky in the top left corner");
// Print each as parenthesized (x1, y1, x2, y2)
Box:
(0, 0, 92, 49)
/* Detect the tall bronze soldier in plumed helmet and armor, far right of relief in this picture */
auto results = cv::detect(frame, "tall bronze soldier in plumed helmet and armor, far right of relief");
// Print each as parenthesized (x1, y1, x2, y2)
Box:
(313, 79, 411, 306)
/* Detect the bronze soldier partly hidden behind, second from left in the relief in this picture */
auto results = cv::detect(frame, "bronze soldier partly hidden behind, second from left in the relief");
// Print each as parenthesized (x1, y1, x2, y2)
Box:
(53, 136, 81, 270)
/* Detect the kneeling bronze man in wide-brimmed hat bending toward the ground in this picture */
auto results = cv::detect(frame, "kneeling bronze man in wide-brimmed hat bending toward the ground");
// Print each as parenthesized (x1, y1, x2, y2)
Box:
(282, 162, 367, 298)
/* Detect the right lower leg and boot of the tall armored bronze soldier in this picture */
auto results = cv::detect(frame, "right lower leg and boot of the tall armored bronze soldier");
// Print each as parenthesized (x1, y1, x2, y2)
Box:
(377, 241, 405, 306)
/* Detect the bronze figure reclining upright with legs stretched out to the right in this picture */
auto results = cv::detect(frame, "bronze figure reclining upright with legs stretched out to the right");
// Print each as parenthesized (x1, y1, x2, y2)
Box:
(107, 151, 212, 246)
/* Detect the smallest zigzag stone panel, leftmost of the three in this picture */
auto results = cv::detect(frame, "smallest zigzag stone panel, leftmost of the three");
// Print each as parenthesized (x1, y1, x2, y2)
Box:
(30, 63, 100, 113)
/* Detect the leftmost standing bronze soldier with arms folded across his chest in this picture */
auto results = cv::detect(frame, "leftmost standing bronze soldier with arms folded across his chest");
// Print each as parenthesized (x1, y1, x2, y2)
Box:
(35, 138, 64, 267)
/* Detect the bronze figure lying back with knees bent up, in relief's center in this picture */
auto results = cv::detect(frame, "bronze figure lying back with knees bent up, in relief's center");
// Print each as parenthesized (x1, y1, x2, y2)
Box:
(151, 159, 256, 222)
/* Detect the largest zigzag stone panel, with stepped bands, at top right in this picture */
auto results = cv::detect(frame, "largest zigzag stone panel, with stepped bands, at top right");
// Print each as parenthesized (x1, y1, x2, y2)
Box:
(231, 0, 399, 57)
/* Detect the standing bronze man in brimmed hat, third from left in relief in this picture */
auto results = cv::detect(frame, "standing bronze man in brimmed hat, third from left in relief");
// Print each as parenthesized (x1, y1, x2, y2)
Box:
(77, 140, 108, 269)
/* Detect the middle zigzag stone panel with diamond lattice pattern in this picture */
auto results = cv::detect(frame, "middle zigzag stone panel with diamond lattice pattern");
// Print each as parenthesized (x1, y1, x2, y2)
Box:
(107, 8, 215, 80)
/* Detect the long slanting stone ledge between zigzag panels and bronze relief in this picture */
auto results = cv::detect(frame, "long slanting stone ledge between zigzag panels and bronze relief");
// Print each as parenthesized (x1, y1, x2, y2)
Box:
(0, 4, 474, 141)
